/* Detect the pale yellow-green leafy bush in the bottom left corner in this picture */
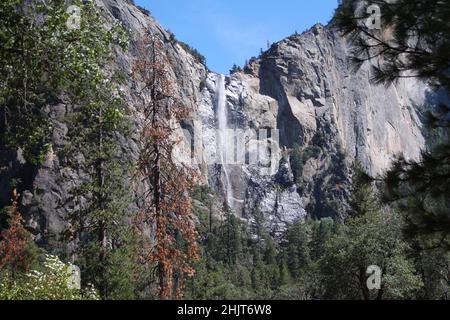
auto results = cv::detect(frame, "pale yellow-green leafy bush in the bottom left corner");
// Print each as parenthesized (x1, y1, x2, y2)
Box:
(0, 255, 99, 300)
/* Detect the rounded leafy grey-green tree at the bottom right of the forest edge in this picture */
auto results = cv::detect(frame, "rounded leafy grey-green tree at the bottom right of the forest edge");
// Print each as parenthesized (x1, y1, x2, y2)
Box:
(319, 212, 423, 299)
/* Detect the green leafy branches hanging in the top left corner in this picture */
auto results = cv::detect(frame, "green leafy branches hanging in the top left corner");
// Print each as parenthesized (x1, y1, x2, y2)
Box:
(0, 0, 123, 164)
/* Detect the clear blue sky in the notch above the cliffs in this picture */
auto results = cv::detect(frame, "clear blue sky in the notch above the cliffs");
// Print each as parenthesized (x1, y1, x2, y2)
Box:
(135, 0, 338, 73)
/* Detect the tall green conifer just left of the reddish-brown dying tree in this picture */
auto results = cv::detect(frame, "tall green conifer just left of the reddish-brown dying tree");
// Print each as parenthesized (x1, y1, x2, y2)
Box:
(53, 3, 135, 299)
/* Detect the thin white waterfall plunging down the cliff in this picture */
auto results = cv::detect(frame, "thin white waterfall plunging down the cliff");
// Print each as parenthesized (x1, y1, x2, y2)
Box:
(216, 74, 234, 208)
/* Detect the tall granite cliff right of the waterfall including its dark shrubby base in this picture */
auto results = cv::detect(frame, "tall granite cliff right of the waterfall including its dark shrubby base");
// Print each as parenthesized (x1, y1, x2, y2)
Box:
(237, 25, 428, 217)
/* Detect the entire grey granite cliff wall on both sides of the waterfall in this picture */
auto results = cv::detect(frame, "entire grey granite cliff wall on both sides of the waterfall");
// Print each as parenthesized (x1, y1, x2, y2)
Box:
(0, 0, 427, 243)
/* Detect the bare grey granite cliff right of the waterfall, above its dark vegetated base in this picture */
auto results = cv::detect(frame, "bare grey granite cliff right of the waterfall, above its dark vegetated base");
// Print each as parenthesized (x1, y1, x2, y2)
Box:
(256, 25, 426, 175)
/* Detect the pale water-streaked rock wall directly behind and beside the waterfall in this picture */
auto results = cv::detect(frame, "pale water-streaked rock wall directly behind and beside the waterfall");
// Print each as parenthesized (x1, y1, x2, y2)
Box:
(198, 73, 300, 232)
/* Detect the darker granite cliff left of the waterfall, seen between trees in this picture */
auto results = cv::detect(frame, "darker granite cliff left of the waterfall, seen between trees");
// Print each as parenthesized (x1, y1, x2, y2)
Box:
(0, 0, 206, 250)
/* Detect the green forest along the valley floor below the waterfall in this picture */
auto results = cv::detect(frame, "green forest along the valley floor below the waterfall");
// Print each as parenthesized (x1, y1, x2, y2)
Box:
(186, 171, 432, 299)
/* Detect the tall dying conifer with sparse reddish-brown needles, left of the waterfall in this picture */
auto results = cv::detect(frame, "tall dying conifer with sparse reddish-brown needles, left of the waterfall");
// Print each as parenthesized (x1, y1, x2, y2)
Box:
(132, 30, 198, 299)
